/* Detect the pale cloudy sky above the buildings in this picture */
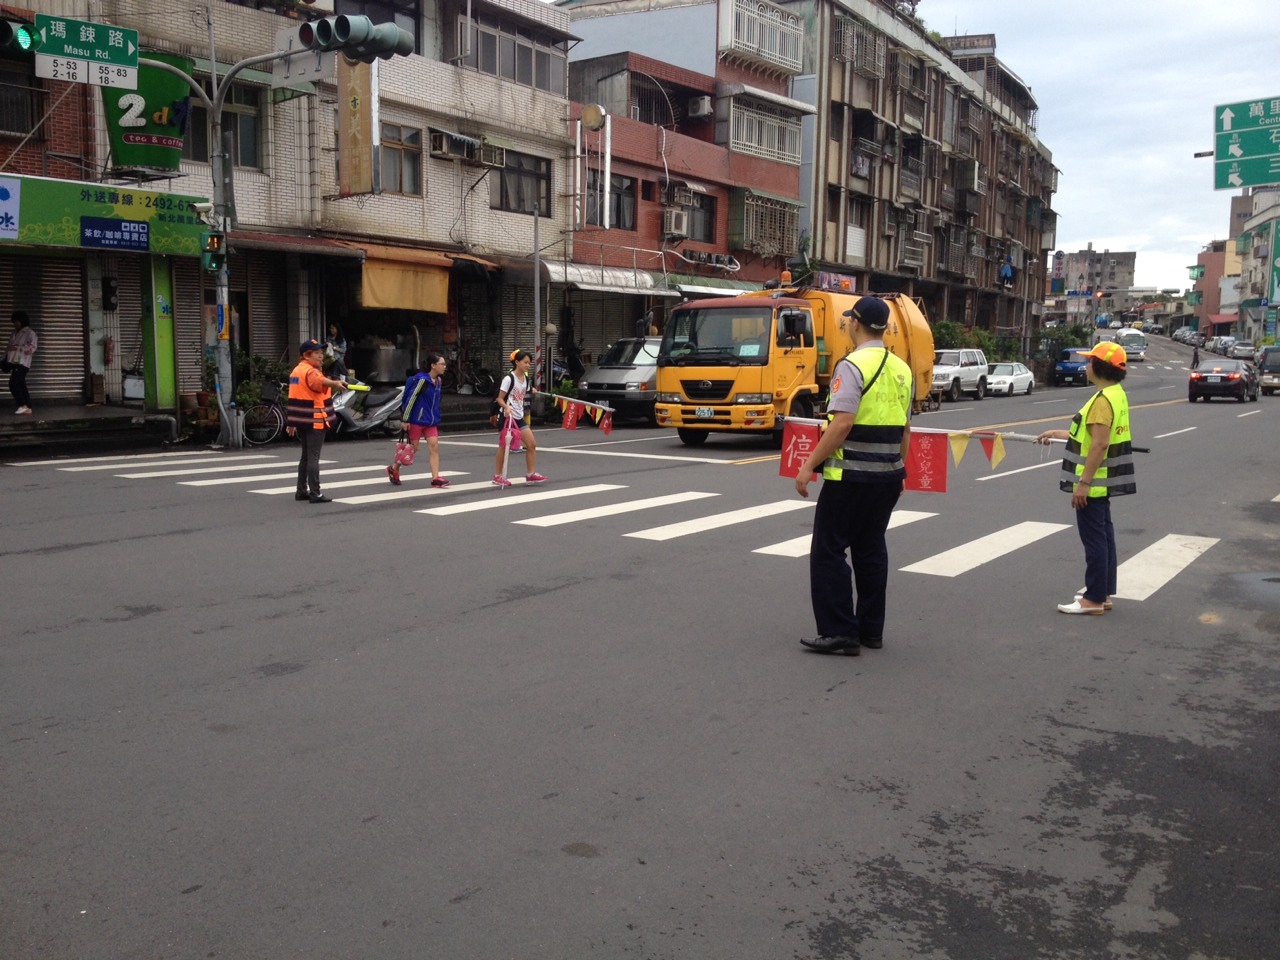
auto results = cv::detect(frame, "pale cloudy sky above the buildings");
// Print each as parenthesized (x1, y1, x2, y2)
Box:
(918, 0, 1280, 289)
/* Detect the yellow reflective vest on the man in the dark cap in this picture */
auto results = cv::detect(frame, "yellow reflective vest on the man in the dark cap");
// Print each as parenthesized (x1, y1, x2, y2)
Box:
(822, 347, 913, 484)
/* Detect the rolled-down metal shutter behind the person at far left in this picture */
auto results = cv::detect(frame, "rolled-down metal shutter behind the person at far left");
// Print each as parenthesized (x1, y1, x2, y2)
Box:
(0, 255, 87, 403)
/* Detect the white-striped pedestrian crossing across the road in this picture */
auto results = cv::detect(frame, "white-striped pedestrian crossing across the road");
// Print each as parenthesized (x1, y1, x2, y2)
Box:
(10, 452, 1219, 600)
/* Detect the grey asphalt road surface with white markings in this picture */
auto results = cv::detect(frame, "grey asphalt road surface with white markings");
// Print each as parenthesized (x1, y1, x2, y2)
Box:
(0, 338, 1280, 960)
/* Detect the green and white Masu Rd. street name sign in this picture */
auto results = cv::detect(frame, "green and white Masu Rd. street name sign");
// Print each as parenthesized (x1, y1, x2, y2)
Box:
(36, 13, 138, 90)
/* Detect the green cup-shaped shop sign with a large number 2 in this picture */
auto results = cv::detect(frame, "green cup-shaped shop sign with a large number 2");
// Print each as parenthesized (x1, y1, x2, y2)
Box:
(102, 51, 193, 173)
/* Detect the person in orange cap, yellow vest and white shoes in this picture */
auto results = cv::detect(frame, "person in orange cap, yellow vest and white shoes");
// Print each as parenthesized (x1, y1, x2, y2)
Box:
(1036, 340, 1138, 617)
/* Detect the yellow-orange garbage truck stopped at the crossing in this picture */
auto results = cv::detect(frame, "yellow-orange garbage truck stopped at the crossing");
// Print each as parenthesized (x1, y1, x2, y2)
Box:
(654, 274, 933, 447)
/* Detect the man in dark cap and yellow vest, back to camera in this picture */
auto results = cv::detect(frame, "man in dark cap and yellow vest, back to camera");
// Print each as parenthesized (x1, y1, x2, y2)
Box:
(796, 296, 913, 657)
